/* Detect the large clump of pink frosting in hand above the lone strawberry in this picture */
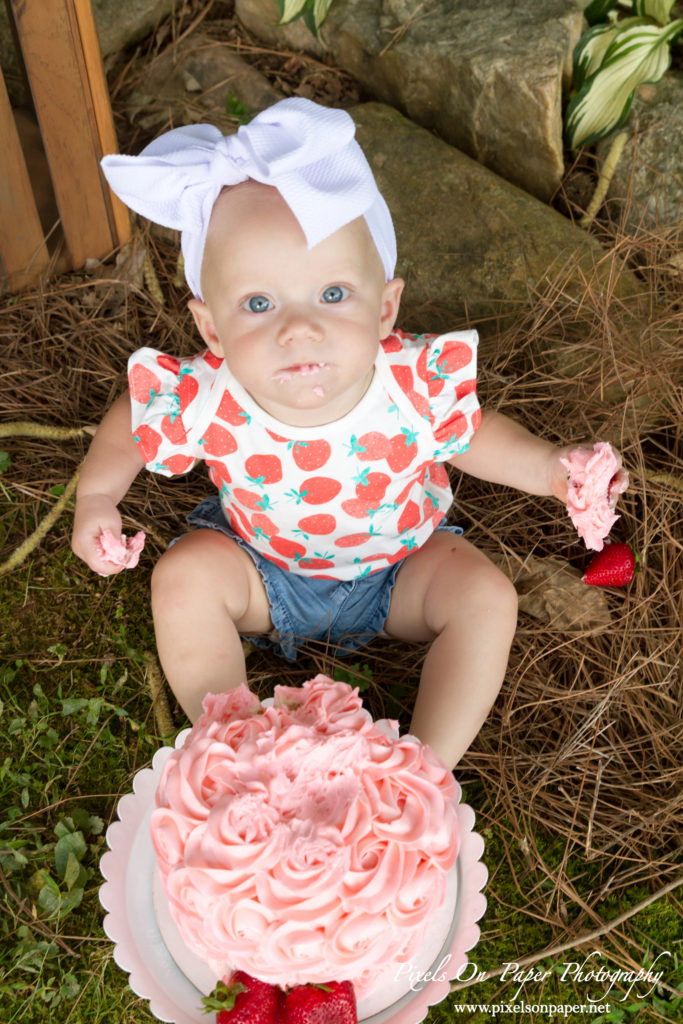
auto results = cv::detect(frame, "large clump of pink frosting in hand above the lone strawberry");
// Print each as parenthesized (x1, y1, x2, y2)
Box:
(561, 441, 629, 551)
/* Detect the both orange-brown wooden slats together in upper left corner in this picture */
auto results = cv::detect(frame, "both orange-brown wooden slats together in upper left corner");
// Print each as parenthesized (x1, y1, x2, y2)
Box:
(0, 0, 130, 291)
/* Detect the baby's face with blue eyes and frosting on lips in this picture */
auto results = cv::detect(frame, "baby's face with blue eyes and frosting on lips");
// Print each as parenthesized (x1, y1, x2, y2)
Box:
(189, 181, 402, 426)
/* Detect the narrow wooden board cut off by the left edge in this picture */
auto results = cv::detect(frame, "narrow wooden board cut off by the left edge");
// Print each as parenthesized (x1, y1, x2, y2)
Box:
(0, 68, 49, 291)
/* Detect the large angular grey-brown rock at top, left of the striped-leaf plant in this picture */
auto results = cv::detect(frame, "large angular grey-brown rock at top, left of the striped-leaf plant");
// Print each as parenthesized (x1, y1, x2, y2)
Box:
(237, 0, 584, 200)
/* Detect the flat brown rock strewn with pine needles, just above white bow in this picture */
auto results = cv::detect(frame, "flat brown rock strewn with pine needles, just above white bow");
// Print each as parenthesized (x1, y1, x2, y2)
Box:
(126, 32, 282, 132)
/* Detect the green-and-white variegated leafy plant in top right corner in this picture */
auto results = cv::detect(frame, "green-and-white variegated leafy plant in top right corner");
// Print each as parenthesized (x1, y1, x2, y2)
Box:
(565, 0, 683, 150)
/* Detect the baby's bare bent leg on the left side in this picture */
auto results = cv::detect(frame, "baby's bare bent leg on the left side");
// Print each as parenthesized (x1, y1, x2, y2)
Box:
(152, 529, 271, 722)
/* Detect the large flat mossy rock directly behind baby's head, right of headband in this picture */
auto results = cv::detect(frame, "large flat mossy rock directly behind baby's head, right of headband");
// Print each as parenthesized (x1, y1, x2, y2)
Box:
(349, 103, 629, 329)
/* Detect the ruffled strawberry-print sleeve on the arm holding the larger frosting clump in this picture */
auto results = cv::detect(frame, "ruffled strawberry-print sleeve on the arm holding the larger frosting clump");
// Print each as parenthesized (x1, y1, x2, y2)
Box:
(422, 331, 481, 462)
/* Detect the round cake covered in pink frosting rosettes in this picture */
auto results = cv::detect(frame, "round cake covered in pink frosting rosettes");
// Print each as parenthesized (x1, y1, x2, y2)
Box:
(152, 676, 458, 994)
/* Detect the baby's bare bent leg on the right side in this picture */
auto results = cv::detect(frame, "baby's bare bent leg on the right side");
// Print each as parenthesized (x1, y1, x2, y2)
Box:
(384, 531, 517, 768)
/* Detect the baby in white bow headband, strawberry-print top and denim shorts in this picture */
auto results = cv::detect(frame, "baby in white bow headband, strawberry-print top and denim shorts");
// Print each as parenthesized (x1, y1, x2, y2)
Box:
(73, 99, 621, 767)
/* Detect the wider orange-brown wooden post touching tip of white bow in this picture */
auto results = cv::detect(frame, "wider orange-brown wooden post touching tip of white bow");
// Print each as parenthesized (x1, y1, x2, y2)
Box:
(10, 0, 130, 267)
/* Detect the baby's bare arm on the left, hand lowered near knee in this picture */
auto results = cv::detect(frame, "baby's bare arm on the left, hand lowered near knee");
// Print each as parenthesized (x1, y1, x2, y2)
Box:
(72, 391, 144, 575)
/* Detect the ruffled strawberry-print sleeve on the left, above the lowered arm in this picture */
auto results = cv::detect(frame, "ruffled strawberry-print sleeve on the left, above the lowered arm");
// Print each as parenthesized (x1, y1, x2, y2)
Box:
(128, 348, 221, 476)
